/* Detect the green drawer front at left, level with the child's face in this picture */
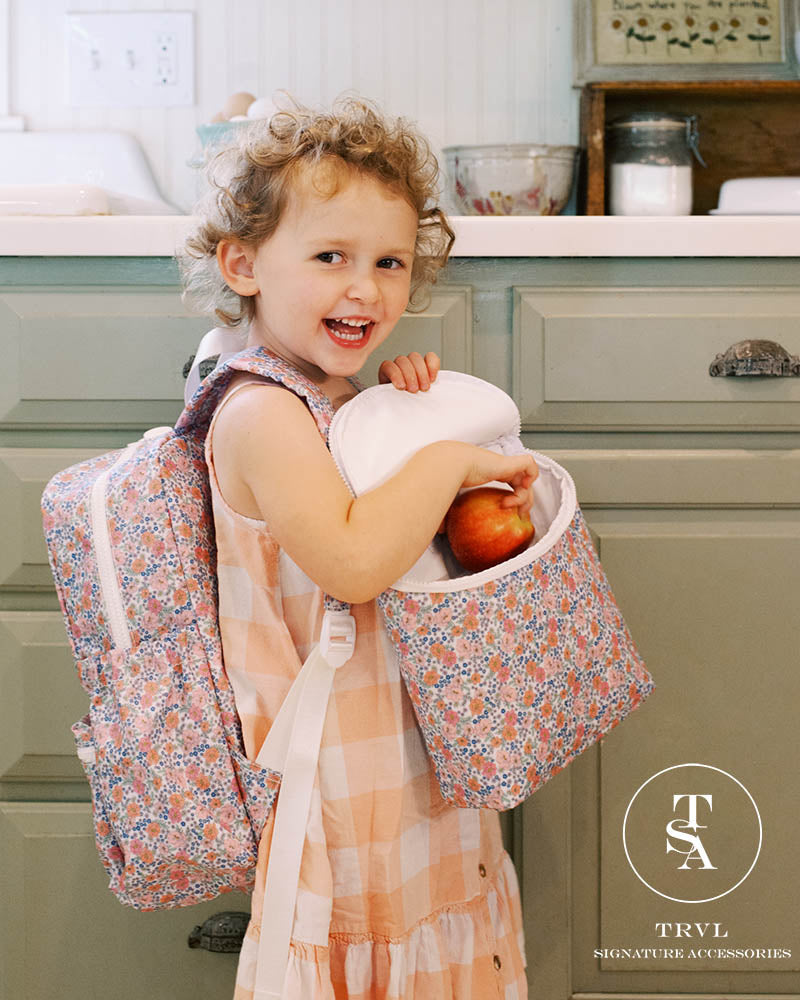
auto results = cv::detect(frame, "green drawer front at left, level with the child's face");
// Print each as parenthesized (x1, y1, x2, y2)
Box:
(0, 288, 212, 429)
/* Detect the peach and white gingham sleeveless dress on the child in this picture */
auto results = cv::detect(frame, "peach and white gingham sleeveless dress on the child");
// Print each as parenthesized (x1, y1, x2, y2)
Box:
(206, 378, 527, 1000)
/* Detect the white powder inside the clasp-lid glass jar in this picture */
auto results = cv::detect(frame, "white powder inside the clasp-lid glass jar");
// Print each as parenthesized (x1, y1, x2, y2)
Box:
(609, 163, 692, 215)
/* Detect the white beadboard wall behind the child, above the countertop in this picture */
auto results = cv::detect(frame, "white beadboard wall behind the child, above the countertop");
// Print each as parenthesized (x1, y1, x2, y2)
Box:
(9, 0, 578, 211)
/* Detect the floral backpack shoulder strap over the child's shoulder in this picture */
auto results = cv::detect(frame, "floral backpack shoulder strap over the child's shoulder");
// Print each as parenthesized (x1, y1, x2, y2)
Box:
(175, 347, 333, 441)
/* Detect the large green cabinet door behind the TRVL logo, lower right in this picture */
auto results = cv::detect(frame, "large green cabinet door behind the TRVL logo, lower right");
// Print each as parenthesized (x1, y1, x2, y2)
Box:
(523, 509, 800, 1000)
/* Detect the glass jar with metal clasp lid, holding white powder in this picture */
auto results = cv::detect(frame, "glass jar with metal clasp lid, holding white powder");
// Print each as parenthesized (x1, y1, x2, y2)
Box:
(607, 111, 706, 215)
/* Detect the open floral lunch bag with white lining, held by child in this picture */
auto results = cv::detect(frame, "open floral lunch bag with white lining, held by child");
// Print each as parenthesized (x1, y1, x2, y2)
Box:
(328, 371, 654, 809)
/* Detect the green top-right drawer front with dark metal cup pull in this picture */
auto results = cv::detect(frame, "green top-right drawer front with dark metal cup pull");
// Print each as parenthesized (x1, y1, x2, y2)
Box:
(513, 287, 800, 430)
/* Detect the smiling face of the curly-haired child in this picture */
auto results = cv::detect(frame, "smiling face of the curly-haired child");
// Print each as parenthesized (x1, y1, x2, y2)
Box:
(231, 168, 418, 380)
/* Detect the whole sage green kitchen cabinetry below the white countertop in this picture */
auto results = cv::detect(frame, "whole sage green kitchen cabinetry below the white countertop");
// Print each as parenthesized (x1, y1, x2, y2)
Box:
(0, 258, 800, 1000)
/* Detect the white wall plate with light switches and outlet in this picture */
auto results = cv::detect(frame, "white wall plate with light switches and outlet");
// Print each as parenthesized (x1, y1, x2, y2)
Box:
(66, 11, 194, 108)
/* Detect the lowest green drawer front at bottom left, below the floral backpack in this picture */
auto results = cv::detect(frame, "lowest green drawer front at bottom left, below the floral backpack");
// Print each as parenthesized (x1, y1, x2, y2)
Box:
(0, 803, 250, 1000)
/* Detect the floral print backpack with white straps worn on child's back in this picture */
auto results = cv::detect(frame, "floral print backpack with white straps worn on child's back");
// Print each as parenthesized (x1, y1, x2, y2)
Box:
(42, 348, 355, 928)
